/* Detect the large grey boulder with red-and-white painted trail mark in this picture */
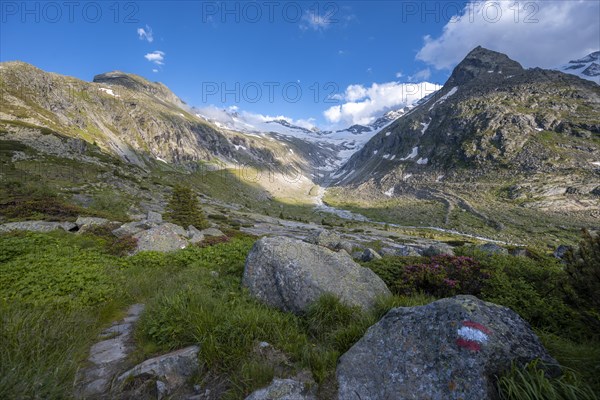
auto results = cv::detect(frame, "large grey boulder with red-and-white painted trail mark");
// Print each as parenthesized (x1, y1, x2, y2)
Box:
(337, 296, 559, 400)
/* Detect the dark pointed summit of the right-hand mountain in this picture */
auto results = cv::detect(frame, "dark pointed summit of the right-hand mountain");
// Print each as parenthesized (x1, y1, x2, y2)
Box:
(447, 46, 524, 86)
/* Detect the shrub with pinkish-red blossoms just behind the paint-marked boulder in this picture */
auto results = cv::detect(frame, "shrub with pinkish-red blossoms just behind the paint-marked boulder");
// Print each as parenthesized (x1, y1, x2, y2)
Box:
(394, 255, 490, 297)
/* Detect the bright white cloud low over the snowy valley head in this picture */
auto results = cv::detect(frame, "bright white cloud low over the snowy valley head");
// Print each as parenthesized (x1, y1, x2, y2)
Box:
(323, 82, 441, 126)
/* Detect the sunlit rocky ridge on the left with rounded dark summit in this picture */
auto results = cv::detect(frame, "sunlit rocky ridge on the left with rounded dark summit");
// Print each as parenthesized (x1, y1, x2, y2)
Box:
(0, 62, 330, 175)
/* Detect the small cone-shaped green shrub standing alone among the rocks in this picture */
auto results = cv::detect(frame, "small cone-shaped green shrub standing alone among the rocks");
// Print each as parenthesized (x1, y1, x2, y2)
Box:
(165, 185, 209, 229)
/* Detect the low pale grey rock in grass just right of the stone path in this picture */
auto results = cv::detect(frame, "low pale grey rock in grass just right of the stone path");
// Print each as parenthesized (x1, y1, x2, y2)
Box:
(116, 346, 200, 397)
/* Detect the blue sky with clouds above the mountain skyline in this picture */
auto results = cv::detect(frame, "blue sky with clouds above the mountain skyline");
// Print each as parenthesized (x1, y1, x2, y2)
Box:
(0, 1, 600, 125)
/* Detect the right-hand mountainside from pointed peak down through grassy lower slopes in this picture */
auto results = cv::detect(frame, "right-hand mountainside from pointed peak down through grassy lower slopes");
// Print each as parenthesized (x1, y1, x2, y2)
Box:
(325, 47, 600, 247)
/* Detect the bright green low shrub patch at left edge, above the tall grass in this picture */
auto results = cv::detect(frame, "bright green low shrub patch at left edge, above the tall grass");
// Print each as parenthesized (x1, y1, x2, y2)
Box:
(0, 232, 118, 308)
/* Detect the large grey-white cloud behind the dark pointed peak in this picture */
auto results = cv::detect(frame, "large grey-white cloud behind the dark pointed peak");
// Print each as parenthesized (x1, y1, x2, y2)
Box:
(416, 0, 600, 69)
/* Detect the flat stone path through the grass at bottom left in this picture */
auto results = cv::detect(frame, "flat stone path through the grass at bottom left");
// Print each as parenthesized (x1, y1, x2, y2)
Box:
(77, 304, 144, 399)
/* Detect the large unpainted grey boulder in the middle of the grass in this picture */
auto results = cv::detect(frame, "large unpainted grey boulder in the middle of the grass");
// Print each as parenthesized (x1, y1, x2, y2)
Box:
(243, 237, 390, 314)
